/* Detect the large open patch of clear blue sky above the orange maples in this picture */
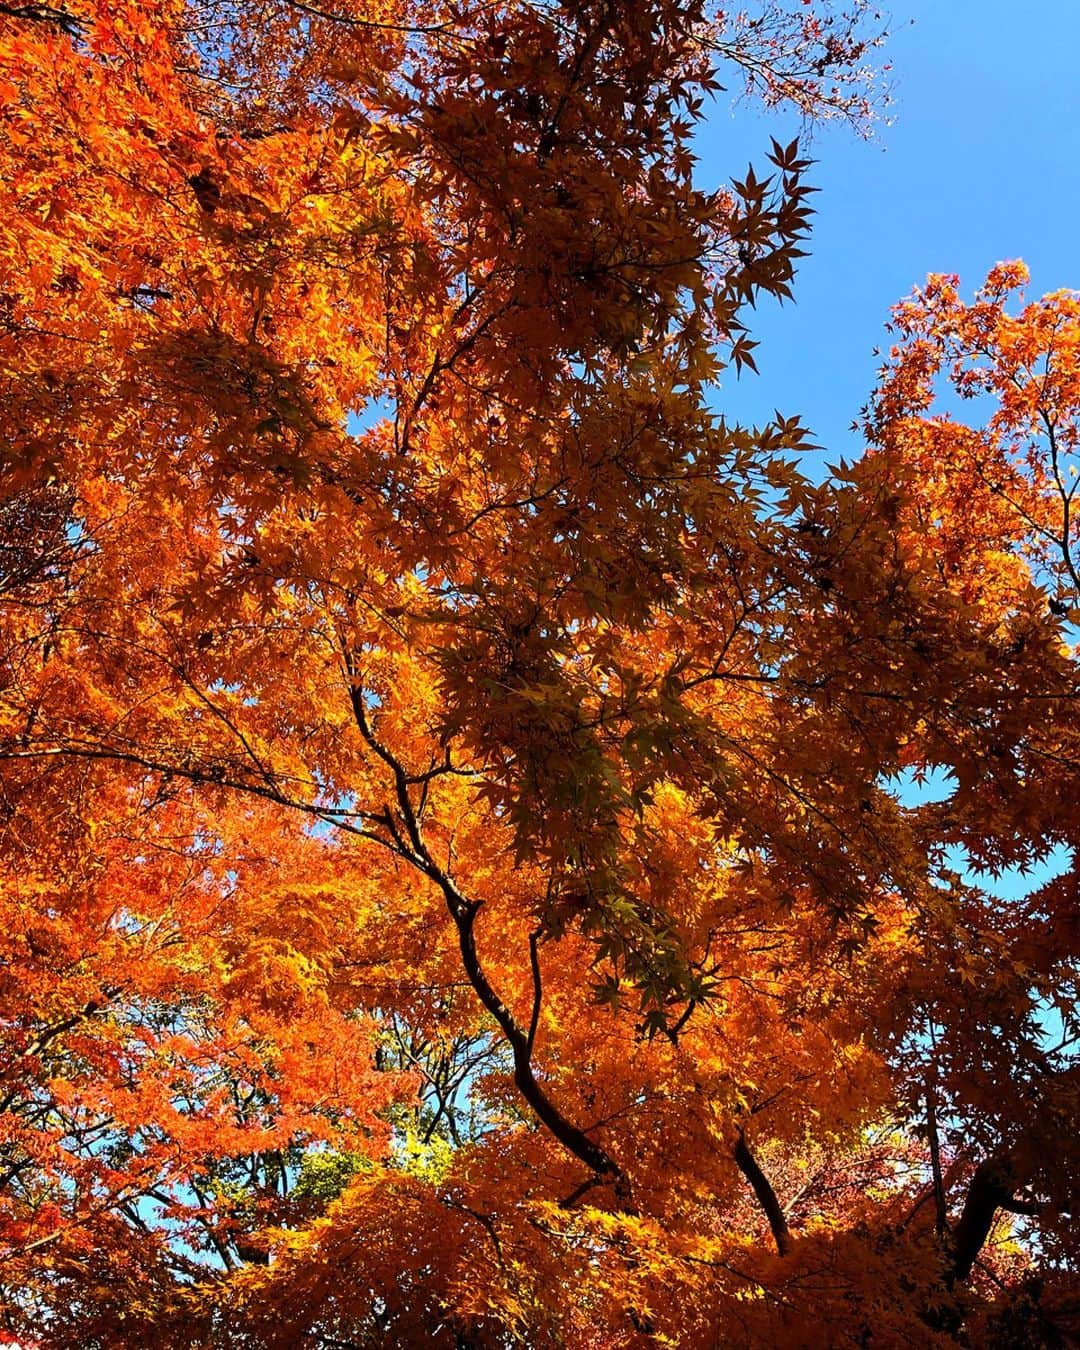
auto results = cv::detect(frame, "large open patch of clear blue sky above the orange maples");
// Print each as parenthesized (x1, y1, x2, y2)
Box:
(698, 0, 1080, 463)
